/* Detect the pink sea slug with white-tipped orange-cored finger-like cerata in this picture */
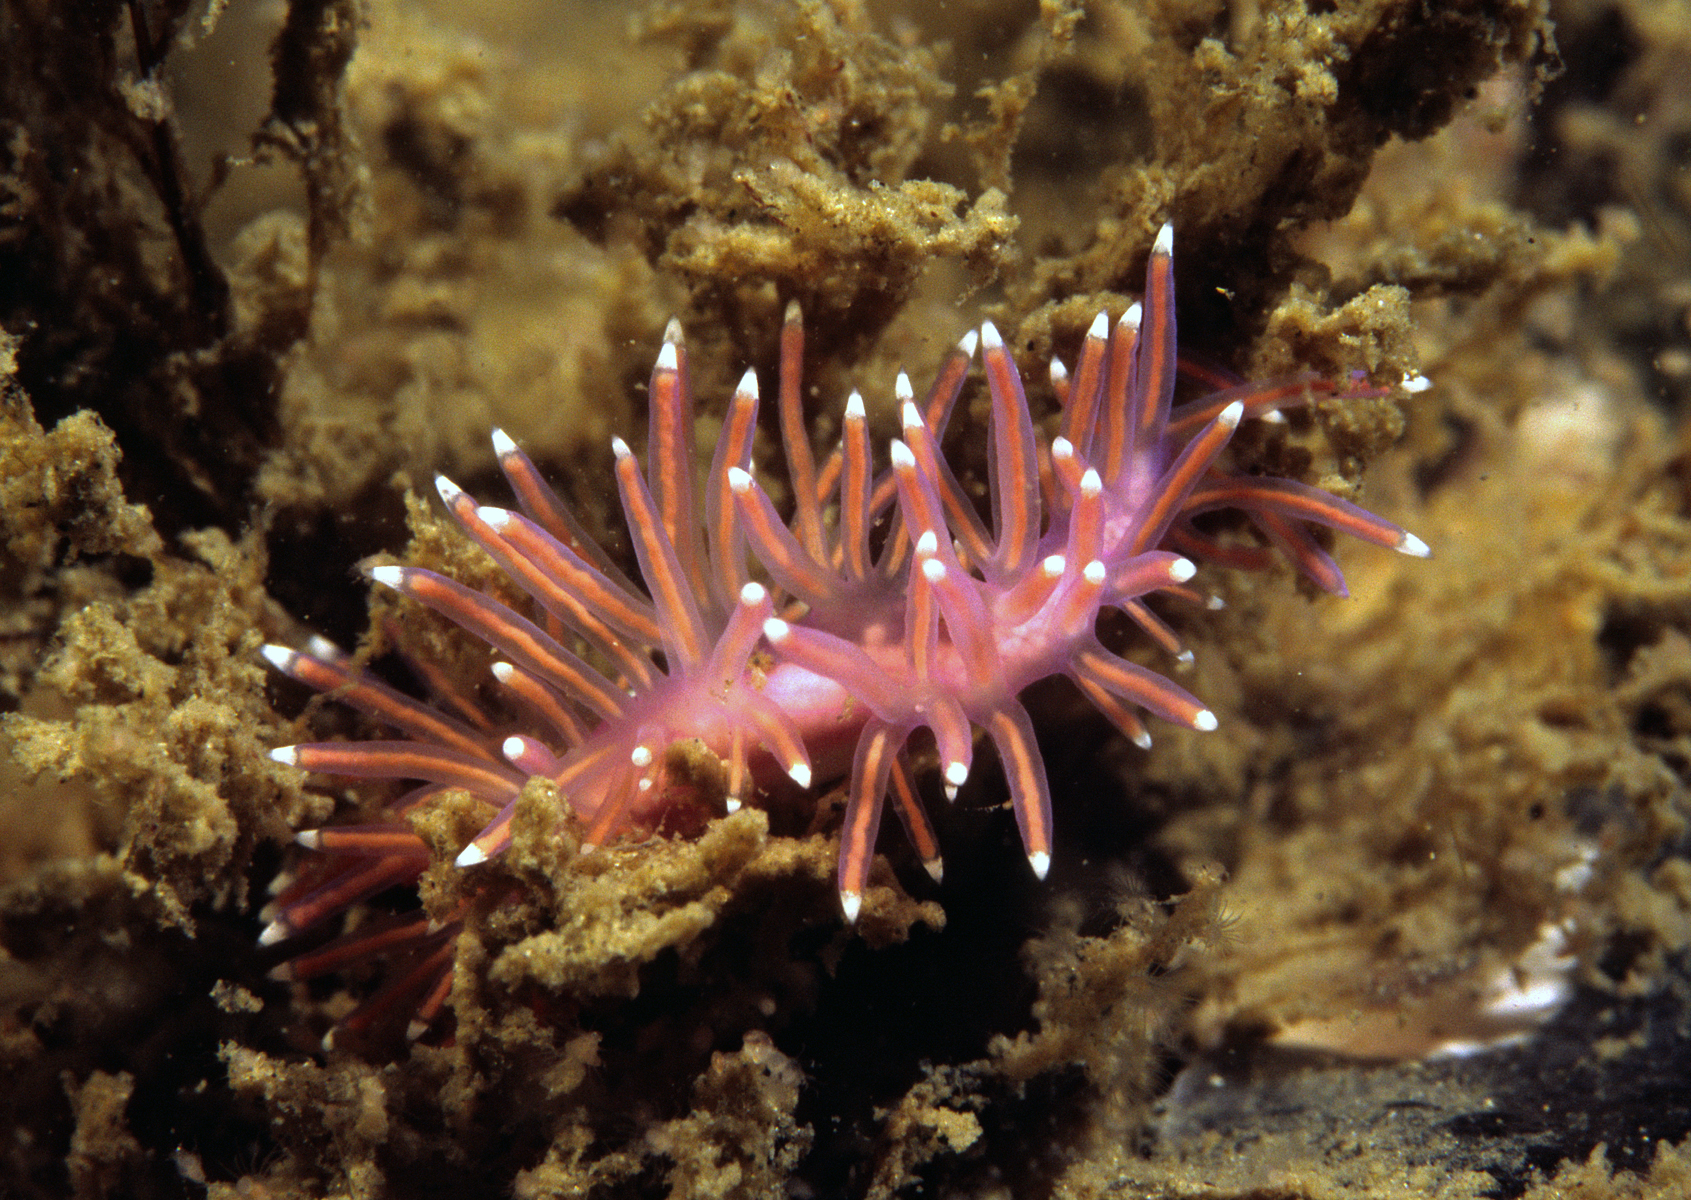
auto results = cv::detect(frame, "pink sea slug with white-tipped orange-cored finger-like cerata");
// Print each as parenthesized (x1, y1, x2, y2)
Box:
(262, 225, 1427, 1033)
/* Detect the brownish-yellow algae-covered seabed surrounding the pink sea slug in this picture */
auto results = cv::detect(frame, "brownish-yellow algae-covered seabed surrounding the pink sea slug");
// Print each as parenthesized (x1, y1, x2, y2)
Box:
(0, 0, 1691, 1200)
